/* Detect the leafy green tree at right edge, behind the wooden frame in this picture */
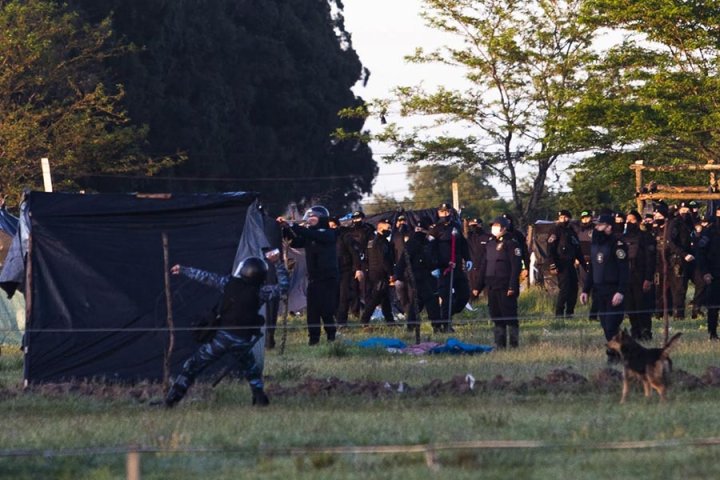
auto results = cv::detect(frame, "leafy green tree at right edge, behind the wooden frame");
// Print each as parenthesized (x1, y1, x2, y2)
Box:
(573, 0, 720, 206)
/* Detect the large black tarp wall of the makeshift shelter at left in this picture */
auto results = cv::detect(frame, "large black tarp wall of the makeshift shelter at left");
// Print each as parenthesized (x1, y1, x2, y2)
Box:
(14, 192, 262, 382)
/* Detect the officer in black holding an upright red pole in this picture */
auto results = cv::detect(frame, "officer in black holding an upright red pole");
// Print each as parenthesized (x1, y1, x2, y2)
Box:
(430, 203, 470, 332)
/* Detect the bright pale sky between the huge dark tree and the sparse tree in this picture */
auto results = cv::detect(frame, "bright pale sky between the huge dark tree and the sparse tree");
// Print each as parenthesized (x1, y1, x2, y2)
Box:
(343, 0, 459, 199)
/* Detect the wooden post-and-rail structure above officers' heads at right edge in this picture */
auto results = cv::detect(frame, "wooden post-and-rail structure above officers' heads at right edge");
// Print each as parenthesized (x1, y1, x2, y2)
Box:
(630, 160, 720, 212)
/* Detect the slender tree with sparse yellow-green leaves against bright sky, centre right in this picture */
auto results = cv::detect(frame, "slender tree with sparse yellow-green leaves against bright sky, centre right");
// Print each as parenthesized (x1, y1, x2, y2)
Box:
(378, 0, 595, 228)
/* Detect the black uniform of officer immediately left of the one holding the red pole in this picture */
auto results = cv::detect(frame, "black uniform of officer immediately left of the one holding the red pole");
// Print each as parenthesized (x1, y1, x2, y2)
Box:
(395, 232, 440, 329)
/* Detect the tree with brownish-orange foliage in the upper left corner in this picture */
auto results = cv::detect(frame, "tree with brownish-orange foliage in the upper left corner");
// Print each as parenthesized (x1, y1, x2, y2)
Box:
(0, 0, 155, 200)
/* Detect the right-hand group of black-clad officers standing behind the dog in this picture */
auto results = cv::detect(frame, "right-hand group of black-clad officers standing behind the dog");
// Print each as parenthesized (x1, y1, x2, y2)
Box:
(548, 201, 720, 360)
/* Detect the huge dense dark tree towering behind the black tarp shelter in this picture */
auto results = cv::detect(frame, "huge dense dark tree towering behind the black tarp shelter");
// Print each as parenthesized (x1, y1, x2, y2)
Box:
(71, 0, 377, 213)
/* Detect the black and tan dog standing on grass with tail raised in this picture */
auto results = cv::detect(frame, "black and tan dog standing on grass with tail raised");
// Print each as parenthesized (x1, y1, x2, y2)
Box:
(607, 329, 682, 403)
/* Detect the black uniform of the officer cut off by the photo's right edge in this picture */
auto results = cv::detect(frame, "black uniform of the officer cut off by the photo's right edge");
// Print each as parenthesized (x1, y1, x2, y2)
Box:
(696, 223, 720, 341)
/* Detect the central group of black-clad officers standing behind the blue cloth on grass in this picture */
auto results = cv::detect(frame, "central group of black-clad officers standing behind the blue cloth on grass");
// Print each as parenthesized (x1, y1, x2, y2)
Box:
(277, 203, 529, 348)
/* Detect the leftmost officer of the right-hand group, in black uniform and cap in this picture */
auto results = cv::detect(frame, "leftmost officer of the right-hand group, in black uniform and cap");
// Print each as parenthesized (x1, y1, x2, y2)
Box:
(548, 210, 584, 318)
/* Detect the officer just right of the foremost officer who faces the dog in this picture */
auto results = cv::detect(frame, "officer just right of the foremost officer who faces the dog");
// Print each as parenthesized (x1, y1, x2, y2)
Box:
(623, 210, 656, 340)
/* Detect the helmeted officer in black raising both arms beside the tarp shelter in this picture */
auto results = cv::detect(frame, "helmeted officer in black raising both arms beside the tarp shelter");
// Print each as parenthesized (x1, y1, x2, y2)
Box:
(277, 205, 339, 345)
